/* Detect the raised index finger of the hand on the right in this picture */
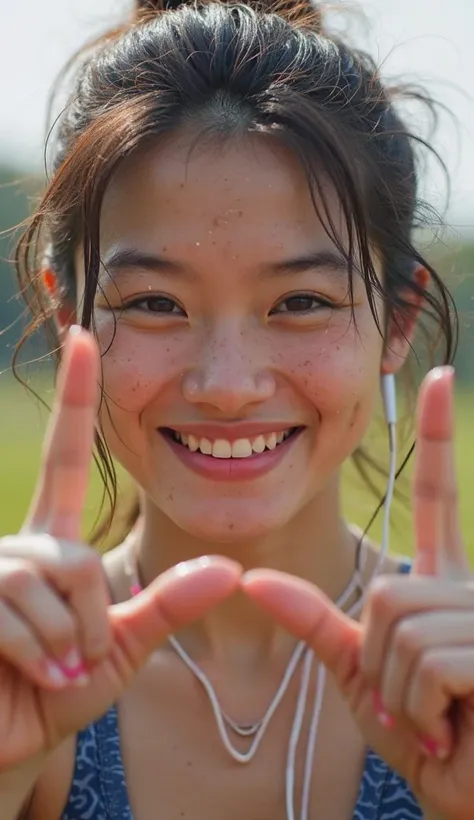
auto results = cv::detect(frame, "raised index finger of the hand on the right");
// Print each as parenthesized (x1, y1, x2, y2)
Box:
(413, 367, 468, 577)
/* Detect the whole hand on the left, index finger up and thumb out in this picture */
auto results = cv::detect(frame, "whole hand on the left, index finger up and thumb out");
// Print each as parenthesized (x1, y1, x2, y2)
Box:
(0, 331, 240, 771)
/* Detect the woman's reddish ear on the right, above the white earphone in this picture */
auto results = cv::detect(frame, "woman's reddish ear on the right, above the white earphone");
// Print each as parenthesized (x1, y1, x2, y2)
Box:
(380, 265, 430, 375)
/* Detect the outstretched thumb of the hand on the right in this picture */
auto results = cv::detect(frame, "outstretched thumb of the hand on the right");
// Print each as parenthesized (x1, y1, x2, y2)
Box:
(241, 569, 361, 690)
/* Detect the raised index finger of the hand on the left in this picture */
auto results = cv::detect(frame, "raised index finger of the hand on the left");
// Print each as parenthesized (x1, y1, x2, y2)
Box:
(28, 327, 100, 540)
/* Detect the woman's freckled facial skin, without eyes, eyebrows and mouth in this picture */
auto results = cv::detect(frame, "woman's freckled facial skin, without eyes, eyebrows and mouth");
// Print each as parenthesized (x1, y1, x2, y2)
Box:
(87, 134, 386, 538)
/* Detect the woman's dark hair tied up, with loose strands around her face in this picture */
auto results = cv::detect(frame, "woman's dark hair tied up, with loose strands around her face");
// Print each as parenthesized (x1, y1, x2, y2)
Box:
(16, 0, 457, 544)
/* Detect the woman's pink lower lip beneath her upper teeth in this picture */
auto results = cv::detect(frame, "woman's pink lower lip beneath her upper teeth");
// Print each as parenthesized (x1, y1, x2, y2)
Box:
(160, 428, 303, 481)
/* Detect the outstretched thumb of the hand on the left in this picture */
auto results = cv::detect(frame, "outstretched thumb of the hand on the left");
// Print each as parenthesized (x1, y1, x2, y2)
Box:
(109, 556, 242, 670)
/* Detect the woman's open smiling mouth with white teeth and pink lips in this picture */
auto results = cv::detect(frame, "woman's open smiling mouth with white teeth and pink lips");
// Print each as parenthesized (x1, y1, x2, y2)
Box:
(159, 427, 305, 481)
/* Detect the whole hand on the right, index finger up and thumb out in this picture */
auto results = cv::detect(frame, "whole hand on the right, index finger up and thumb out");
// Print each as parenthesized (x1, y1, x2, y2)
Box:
(243, 368, 474, 820)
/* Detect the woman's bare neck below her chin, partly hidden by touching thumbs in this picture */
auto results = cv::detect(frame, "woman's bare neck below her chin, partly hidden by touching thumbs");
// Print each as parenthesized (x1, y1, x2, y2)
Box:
(133, 480, 357, 665)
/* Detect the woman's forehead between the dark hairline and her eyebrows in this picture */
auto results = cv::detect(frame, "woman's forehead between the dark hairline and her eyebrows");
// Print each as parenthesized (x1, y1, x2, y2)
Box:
(101, 134, 345, 252)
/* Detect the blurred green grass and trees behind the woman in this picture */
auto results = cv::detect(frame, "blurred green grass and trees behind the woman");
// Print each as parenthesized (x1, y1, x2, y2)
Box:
(0, 160, 474, 563)
